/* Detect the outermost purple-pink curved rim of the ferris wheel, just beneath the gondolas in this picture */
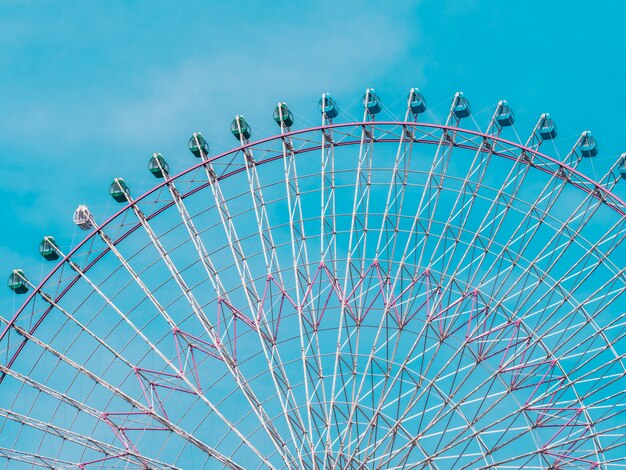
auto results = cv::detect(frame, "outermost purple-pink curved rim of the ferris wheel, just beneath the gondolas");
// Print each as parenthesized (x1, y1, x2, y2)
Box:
(0, 121, 626, 364)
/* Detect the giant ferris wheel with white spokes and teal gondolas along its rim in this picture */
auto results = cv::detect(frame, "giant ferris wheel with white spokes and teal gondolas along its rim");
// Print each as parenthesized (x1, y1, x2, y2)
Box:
(0, 88, 626, 469)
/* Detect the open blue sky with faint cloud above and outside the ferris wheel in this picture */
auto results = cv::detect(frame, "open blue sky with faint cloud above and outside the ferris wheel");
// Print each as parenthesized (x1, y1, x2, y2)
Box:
(0, 0, 626, 296)
